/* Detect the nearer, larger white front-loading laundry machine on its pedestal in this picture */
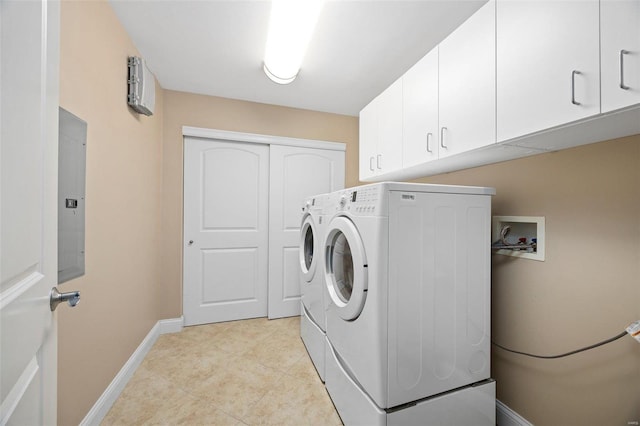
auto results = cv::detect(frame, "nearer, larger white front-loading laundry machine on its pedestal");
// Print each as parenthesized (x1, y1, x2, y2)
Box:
(323, 183, 495, 425)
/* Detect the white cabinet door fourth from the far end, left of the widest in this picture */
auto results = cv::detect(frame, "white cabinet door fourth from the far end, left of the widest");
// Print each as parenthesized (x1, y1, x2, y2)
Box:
(439, 1, 496, 158)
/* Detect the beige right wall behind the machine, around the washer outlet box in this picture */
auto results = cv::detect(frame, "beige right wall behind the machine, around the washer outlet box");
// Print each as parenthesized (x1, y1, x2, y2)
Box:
(412, 135, 640, 425)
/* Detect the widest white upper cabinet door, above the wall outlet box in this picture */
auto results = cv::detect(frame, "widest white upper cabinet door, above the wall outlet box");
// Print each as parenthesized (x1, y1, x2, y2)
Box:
(496, 0, 600, 142)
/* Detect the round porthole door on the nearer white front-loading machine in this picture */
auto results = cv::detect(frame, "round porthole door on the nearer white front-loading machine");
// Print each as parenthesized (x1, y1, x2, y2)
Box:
(325, 217, 368, 320)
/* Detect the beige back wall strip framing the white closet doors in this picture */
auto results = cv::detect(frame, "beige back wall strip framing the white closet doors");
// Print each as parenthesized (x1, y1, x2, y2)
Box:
(161, 91, 358, 318)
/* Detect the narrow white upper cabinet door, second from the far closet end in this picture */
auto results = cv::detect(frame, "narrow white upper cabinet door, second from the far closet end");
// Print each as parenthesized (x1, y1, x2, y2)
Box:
(376, 79, 402, 173)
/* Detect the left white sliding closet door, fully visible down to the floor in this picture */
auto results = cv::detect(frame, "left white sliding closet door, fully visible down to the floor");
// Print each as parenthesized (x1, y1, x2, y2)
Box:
(183, 138, 269, 325)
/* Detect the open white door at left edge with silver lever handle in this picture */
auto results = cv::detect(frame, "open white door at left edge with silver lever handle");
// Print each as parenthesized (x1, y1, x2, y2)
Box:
(0, 0, 60, 425)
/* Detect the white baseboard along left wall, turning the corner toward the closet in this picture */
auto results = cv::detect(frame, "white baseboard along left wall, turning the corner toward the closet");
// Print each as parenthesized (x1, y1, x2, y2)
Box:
(80, 317, 184, 426)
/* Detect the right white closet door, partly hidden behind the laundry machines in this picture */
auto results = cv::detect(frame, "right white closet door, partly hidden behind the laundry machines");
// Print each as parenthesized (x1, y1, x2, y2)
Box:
(269, 145, 344, 318)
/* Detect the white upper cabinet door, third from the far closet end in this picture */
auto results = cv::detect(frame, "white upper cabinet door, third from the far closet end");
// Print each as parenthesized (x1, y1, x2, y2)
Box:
(402, 46, 440, 167)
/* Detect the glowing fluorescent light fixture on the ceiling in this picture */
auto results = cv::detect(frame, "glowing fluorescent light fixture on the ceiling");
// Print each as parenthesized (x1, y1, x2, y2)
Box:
(264, 0, 323, 84)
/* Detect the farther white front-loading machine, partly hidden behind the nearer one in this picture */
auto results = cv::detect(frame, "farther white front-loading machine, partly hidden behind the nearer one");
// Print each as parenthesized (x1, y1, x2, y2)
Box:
(299, 195, 326, 382)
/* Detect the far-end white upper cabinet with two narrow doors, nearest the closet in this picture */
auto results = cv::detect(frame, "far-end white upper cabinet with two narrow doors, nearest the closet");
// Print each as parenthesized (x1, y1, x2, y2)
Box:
(360, 79, 402, 180)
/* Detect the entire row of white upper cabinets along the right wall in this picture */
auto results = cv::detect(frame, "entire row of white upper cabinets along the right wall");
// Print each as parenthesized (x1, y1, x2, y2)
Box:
(360, 0, 640, 181)
